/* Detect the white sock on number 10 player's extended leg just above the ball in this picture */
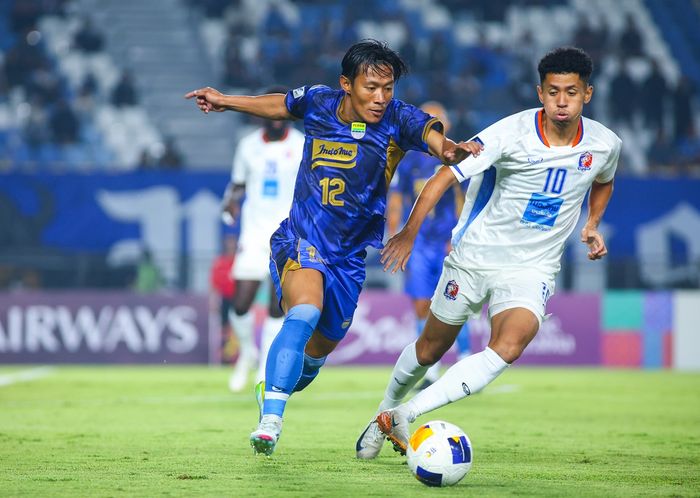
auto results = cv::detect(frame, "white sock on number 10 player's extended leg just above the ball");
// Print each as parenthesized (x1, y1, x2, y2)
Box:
(404, 346, 509, 418)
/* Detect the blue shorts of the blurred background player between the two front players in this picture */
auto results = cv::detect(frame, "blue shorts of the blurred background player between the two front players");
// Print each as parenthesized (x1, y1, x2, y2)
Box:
(404, 240, 447, 299)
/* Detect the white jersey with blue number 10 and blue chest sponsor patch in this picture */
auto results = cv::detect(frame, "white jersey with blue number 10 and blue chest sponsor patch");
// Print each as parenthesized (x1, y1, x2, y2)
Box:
(448, 109, 621, 274)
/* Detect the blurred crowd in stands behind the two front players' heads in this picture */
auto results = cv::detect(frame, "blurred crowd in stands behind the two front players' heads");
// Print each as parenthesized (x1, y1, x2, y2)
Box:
(190, 0, 700, 174)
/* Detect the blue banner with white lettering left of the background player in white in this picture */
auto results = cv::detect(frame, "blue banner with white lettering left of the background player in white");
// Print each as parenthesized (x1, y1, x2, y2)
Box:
(0, 172, 229, 291)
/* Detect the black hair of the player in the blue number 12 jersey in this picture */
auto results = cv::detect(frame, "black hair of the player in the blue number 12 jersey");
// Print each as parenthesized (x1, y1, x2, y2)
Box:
(341, 39, 408, 81)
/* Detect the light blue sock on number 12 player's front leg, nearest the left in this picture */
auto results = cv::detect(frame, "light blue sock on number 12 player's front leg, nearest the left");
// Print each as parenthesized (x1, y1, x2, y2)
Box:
(263, 304, 325, 417)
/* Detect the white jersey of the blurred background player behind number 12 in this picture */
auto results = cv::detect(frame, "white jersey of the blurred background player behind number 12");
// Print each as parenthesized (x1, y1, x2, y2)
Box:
(231, 127, 304, 247)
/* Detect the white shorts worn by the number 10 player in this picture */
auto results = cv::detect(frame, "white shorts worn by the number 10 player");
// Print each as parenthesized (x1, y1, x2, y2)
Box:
(430, 258, 554, 325)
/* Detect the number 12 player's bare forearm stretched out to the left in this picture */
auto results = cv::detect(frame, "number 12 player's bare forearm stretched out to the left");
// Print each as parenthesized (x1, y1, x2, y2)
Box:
(185, 86, 294, 120)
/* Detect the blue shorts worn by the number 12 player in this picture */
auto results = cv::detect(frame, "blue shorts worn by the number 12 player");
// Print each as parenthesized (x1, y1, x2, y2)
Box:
(270, 220, 366, 341)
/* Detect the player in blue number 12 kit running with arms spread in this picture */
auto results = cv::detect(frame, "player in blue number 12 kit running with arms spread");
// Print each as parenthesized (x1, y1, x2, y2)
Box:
(185, 40, 481, 455)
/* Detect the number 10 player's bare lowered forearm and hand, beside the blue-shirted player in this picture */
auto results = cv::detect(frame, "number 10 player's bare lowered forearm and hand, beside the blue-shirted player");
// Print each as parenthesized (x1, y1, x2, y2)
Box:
(380, 166, 457, 273)
